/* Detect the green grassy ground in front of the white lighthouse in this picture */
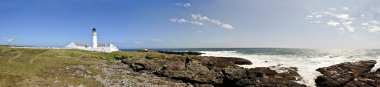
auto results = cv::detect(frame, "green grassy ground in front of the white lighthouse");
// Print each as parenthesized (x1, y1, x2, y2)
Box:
(0, 46, 162, 87)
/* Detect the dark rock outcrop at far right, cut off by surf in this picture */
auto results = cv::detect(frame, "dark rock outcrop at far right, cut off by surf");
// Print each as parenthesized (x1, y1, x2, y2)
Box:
(315, 60, 380, 87)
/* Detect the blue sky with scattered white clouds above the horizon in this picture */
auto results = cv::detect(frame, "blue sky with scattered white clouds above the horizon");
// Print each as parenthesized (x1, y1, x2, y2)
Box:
(0, 0, 380, 49)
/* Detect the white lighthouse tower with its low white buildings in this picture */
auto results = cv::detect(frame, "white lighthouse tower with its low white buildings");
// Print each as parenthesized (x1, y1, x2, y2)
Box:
(65, 28, 119, 53)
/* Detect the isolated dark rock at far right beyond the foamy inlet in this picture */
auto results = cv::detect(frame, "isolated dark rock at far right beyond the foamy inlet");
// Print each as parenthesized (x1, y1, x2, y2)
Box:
(315, 60, 376, 87)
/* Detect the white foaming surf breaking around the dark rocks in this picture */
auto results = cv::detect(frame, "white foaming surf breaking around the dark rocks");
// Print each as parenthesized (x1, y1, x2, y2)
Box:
(200, 51, 380, 87)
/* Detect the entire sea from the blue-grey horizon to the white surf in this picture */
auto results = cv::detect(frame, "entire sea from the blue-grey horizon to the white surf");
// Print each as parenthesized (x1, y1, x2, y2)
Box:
(121, 48, 380, 87)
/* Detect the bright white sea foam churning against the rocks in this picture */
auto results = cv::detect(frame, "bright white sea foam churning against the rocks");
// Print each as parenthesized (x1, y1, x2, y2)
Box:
(199, 50, 380, 87)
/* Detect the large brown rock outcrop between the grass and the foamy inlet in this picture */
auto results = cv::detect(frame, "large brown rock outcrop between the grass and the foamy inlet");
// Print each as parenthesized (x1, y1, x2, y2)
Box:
(118, 55, 305, 87)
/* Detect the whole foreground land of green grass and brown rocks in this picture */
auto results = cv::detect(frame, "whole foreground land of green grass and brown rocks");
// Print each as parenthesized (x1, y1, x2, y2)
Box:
(0, 47, 380, 87)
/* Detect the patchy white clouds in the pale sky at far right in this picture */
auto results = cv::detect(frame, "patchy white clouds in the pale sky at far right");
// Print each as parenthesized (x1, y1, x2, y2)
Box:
(306, 6, 380, 33)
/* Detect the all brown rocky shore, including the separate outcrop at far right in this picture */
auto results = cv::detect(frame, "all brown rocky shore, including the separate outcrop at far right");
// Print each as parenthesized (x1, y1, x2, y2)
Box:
(114, 51, 380, 87)
